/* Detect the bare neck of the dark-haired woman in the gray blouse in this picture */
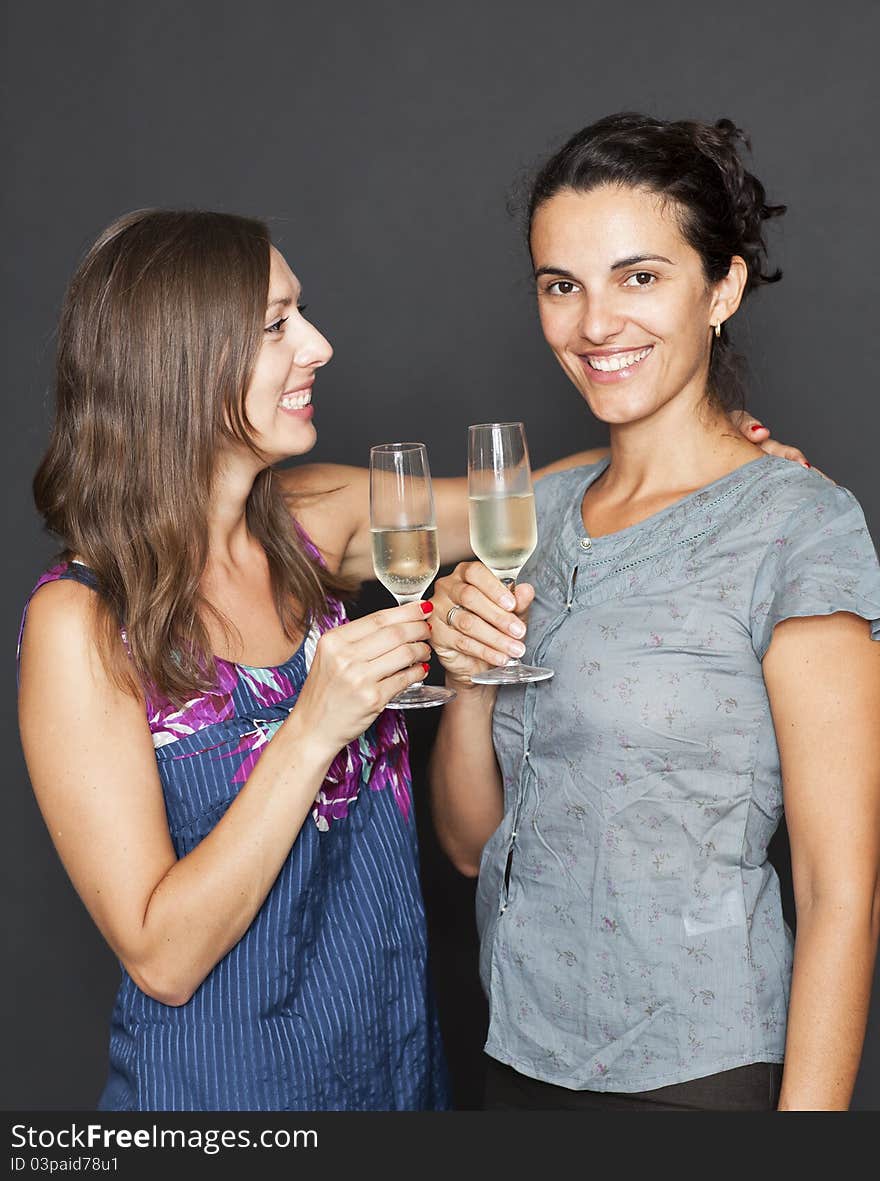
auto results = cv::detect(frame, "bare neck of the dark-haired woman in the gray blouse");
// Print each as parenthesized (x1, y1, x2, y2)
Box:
(602, 377, 761, 498)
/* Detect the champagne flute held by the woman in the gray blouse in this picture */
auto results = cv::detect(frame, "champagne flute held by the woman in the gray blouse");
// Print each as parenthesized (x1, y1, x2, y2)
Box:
(468, 423, 553, 685)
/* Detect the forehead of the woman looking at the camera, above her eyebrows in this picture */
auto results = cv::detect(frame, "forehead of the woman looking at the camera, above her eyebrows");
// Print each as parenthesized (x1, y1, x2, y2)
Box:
(530, 185, 691, 267)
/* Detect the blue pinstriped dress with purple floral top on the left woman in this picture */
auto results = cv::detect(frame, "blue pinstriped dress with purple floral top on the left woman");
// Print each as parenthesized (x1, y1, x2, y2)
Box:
(21, 557, 449, 1111)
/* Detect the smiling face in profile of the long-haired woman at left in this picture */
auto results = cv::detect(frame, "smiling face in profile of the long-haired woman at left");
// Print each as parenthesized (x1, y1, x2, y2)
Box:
(239, 247, 333, 463)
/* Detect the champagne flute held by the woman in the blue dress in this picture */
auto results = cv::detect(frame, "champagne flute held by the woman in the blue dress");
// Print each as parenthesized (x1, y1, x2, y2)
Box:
(370, 443, 455, 710)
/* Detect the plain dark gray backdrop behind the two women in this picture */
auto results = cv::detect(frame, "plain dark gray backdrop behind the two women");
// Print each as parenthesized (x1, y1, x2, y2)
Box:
(0, 0, 880, 1109)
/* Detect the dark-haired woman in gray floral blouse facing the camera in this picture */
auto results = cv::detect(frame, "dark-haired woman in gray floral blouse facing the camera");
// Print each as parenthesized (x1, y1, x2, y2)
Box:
(431, 115, 880, 1110)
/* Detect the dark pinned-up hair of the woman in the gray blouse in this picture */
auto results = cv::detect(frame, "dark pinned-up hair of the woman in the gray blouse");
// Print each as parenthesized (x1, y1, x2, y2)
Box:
(527, 111, 786, 410)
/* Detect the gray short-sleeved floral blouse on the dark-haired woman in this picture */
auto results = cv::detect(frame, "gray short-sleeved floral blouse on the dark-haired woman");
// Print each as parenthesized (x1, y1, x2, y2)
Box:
(477, 456, 880, 1091)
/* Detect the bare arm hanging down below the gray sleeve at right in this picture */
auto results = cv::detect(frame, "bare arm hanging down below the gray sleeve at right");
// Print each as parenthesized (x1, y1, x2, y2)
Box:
(763, 613, 880, 1110)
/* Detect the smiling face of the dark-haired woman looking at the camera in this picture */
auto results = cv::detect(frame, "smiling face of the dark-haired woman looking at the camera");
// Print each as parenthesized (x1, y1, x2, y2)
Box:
(530, 185, 745, 424)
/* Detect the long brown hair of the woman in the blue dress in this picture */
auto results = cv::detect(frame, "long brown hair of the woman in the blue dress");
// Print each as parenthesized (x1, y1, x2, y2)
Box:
(33, 209, 352, 704)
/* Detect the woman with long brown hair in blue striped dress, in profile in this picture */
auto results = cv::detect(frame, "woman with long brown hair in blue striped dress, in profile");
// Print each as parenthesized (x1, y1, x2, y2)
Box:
(20, 200, 798, 1110)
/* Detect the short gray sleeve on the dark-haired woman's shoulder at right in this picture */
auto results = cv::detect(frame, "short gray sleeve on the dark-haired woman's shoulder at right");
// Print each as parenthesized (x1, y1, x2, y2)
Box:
(750, 483, 880, 660)
